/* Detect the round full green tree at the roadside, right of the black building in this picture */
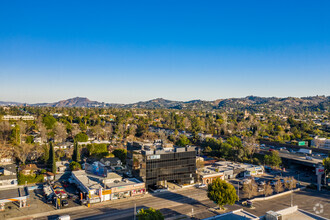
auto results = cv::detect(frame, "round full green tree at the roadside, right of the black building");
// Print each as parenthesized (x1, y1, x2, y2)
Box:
(207, 178, 238, 209)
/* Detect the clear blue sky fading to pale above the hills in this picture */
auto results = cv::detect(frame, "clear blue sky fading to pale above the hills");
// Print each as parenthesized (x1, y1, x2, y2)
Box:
(0, 0, 330, 103)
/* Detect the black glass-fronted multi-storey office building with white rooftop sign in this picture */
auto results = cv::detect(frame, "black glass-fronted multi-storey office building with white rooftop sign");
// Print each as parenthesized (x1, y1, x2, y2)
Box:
(126, 141, 196, 188)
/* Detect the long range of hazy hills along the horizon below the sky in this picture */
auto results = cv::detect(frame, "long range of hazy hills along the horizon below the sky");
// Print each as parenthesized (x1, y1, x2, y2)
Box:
(0, 96, 330, 111)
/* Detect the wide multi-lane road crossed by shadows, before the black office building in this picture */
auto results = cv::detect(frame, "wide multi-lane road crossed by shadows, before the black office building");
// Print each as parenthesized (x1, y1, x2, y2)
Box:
(38, 188, 224, 220)
